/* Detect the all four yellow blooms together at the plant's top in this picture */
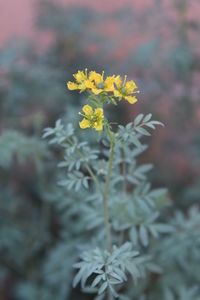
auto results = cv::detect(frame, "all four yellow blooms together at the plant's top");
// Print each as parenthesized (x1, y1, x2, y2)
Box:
(67, 69, 137, 131)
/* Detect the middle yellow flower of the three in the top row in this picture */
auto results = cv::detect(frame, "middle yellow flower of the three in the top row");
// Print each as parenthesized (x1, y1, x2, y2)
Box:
(89, 71, 115, 95)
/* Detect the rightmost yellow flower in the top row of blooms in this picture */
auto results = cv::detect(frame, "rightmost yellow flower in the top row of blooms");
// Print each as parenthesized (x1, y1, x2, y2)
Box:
(114, 75, 137, 104)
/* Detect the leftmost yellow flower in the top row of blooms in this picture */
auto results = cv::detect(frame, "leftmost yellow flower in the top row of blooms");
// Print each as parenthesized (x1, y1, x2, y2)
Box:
(67, 69, 94, 91)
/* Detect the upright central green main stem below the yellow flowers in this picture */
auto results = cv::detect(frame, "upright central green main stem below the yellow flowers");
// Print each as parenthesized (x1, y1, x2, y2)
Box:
(103, 127, 115, 250)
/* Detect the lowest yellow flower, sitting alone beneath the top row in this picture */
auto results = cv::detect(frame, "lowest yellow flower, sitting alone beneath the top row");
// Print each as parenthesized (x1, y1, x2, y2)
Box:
(79, 105, 104, 131)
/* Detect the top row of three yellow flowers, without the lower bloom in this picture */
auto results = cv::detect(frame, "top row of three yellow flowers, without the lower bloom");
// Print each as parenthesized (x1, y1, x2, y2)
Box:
(67, 69, 137, 104)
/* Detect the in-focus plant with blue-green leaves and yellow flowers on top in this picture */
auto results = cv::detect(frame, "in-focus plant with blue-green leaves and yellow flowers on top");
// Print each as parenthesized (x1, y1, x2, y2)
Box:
(44, 69, 176, 300)
